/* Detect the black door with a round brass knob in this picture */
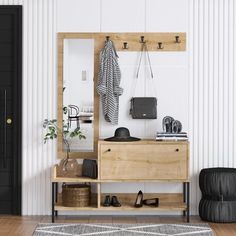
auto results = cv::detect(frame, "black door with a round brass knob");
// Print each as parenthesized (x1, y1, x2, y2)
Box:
(0, 6, 22, 214)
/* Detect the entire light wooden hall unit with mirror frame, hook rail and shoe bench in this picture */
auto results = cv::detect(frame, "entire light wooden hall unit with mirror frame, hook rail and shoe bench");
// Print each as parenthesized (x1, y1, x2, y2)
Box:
(52, 32, 190, 222)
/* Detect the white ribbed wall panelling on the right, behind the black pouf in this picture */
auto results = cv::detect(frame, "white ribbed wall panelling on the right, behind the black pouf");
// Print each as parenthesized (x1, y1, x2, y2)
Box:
(189, 0, 236, 213)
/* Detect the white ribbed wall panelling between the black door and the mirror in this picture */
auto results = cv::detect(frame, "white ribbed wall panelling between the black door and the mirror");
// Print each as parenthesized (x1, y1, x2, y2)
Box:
(0, 0, 57, 215)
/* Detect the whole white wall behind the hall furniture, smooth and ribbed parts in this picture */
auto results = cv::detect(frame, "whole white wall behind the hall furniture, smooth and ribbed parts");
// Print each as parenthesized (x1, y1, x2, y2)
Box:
(0, 0, 236, 215)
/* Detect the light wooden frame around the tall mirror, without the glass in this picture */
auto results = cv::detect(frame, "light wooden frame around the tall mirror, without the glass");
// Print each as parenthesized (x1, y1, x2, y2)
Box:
(57, 33, 99, 159)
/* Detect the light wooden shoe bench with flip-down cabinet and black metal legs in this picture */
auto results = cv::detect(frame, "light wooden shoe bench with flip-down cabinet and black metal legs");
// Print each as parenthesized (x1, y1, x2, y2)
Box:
(52, 140, 190, 222)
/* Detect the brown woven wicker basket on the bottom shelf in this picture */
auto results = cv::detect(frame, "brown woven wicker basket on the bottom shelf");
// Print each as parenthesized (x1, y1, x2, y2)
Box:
(62, 184, 90, 207)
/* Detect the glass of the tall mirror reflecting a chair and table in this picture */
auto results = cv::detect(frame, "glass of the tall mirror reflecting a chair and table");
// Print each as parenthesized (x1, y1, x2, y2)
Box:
(63, 39, 94, 152)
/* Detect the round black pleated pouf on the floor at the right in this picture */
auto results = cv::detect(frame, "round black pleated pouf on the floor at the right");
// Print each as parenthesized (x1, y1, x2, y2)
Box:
(199, 168, 236, 223)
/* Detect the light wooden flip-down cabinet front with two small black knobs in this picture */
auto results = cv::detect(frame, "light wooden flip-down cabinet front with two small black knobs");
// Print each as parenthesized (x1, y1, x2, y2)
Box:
(100, 144, 188, 180)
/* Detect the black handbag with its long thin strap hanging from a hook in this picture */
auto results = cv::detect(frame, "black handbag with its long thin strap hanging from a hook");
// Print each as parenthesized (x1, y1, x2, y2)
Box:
(130, 42, 157, 119)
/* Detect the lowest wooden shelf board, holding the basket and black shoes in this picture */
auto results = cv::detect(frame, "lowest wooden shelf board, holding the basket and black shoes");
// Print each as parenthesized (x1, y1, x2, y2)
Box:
(55, 202, 187, 211)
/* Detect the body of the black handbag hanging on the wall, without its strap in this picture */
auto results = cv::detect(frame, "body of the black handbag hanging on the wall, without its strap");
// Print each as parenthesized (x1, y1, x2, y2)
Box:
(130, 97, 157, 119)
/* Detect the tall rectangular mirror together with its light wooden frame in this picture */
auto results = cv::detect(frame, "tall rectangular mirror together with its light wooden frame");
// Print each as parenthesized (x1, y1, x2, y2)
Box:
(58, 33, 99, 158)
